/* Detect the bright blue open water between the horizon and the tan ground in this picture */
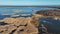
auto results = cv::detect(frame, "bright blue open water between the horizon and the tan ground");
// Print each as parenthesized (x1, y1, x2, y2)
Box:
(0, 7, 56, 20)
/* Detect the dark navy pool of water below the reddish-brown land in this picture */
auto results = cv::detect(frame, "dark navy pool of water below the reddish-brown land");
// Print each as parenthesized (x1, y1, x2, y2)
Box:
(39, 18, 60, 34)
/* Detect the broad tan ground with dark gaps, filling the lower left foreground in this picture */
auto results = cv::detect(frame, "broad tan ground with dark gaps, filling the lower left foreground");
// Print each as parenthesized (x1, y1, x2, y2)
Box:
(0, 14, 38, 34)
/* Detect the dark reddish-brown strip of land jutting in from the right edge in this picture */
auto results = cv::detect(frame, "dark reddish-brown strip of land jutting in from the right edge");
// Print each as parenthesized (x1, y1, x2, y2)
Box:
(36, 10, 60, 16)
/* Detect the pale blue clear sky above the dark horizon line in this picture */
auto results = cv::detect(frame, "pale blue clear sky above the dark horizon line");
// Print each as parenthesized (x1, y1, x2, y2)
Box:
(0, 0, 60, 6)
